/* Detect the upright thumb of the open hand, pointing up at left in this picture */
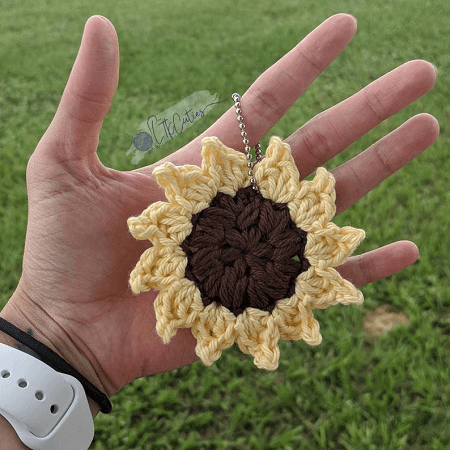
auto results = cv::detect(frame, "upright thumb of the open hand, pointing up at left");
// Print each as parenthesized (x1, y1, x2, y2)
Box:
(35, 16, 119, 161)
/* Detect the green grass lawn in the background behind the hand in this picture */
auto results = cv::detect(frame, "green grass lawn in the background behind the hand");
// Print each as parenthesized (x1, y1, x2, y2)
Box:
(0, 0, 450, 450)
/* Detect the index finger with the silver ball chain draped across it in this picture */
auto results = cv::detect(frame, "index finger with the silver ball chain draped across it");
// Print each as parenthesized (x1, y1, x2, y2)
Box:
(144, 14, 357, 173)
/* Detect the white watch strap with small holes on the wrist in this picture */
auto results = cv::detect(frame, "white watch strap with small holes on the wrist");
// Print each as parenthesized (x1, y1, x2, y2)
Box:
(0, 344, 94, 450)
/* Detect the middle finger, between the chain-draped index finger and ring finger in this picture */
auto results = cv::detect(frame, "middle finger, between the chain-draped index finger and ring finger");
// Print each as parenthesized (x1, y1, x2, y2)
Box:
(286, 60, 437, 178)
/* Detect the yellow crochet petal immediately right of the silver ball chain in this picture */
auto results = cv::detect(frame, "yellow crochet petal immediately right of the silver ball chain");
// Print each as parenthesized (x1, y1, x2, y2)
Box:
(254, 136, 300, 203)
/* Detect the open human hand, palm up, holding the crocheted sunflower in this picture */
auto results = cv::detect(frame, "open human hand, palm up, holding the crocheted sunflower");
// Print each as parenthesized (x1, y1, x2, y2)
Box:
(1, 14, 438, 416)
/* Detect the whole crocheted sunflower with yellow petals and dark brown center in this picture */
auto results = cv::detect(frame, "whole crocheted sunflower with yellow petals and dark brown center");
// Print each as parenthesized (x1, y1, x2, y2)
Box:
(128, 136, 365, 370)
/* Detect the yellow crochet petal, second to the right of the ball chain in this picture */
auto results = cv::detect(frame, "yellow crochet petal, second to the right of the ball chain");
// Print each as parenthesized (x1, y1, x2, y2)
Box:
(288, 167, 336, 232)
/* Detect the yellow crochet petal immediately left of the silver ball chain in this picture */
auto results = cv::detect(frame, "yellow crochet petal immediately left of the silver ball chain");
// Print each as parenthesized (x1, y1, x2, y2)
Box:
(202, 137, 248, 197)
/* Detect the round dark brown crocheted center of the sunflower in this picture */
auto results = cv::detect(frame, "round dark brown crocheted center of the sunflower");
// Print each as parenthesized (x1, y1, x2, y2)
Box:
(181, 186, 310, 316)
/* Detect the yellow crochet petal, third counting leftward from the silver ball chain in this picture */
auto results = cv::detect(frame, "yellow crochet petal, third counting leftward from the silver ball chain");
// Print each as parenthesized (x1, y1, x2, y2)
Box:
(127, 202, 192, 245)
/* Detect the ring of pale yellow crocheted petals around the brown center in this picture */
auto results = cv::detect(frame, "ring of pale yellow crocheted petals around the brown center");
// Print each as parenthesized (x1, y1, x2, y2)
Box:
(128, 137, 365, 370)
